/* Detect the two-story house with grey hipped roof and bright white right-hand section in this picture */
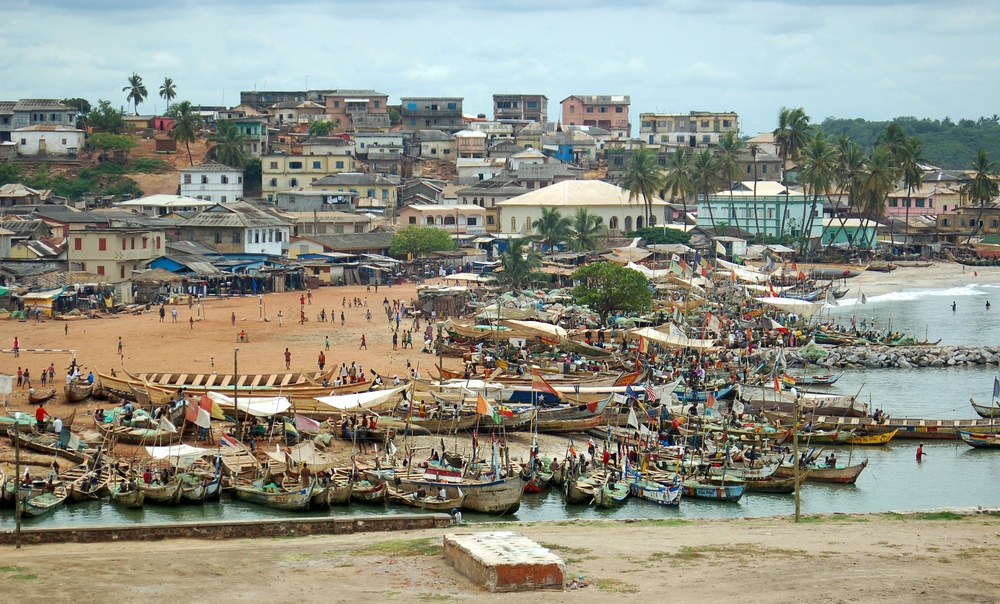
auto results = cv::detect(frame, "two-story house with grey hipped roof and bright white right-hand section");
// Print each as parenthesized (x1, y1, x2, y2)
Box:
(178, 201, 291, 256)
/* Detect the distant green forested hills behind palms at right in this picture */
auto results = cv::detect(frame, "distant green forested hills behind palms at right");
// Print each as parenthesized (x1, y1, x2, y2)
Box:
(817, 115, 1000, 169)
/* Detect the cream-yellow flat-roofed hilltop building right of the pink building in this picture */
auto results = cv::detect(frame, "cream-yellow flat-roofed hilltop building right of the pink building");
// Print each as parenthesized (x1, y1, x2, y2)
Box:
(639, 111, 740, 148)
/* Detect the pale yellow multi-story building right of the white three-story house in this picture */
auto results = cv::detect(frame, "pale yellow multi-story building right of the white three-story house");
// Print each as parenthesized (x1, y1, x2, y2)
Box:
(261, 145, 355, 201)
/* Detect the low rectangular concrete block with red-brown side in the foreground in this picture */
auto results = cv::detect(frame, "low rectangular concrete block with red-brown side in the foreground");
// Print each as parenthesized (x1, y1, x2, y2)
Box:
(444, 531, 566, 592)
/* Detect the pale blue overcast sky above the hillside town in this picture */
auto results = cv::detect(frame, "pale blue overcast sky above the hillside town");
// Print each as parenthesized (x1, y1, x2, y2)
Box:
(0, 0, 1000, 135)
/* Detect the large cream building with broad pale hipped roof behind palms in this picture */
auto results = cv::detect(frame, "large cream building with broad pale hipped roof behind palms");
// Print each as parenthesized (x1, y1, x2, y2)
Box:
(497, 180, 670, 234)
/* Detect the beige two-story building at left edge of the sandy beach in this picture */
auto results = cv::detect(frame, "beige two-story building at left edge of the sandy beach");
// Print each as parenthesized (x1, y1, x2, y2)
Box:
(67, 226, 166, 283)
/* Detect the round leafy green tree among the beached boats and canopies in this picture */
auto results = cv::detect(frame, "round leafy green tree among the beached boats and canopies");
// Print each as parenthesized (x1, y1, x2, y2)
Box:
(571, 262, 653, 323)
